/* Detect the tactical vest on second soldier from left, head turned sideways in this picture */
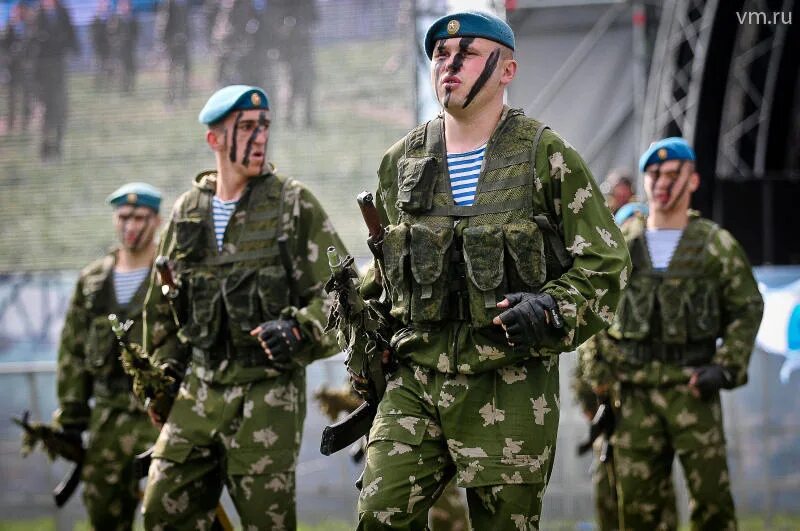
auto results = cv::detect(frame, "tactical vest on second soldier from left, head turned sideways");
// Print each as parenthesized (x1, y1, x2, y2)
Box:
(173, 172, 294, 368)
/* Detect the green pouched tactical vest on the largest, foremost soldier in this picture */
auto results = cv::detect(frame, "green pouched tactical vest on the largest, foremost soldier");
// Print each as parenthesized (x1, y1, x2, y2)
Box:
(383, 109, 570, 327)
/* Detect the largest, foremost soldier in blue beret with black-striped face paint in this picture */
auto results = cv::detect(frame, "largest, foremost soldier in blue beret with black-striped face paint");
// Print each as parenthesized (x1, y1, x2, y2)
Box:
(358, 12, 629, 529)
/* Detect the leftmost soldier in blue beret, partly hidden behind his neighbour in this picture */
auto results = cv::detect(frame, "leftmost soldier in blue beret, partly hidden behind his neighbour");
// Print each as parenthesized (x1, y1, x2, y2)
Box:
(54, 183, 161, 529)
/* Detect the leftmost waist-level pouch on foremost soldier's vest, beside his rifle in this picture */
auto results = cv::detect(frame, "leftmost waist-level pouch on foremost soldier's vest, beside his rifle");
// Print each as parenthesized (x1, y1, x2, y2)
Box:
(383, 223, 411, 324)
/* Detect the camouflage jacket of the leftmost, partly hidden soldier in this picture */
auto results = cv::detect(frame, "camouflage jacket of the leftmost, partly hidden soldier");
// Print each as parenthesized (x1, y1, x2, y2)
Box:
(55, 251, 148, 429)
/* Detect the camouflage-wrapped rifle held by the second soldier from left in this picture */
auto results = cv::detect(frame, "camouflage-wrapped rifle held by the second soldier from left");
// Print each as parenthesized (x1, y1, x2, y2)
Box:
(108, 312, 178, 418)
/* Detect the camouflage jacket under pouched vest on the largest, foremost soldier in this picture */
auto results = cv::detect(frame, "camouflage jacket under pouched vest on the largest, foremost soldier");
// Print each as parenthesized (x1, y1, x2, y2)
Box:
(376, 107, 630, 373)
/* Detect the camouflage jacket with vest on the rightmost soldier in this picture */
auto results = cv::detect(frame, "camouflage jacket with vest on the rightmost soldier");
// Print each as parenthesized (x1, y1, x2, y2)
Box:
(579, 211, 764, 387)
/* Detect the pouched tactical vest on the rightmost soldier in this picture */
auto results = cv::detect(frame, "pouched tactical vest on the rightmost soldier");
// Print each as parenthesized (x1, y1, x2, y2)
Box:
(608, 215, 721, 366)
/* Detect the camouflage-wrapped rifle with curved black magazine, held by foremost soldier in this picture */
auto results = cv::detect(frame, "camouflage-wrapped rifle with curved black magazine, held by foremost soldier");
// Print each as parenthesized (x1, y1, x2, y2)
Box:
(320, 247, 389, 455)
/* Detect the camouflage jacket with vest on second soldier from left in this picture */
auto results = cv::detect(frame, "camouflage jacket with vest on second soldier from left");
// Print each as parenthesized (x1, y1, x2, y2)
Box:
(144, 168, 345, 384)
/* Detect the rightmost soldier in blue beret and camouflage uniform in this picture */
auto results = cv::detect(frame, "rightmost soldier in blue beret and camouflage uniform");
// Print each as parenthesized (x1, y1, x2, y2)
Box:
(580, 138, 763, 530)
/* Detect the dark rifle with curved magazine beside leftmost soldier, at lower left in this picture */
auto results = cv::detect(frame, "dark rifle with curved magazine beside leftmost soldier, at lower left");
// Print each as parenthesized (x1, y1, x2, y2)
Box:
(11, 411, 86, 507)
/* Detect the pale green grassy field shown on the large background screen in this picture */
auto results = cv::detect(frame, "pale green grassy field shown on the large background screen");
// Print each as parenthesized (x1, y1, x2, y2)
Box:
(0, 40, 413, 271)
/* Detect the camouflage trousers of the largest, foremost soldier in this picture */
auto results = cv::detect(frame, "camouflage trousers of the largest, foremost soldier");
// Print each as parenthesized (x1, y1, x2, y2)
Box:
(358, 360, 558, 530)
